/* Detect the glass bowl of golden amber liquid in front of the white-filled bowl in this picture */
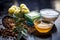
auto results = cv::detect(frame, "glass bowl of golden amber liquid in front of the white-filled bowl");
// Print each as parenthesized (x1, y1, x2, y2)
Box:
(34, 20, 53, 33)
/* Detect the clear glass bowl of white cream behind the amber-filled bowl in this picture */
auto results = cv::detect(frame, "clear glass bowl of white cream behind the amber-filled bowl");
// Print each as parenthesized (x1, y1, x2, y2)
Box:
(40, 9, 59, 21)
